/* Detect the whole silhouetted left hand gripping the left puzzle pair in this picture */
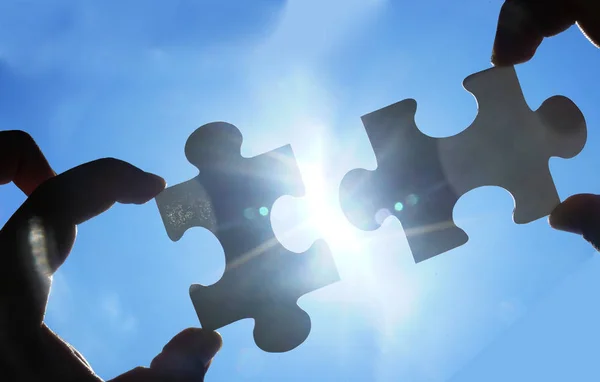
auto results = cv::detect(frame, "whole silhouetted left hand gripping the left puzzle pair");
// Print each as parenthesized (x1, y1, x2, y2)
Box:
(0, 131, 221, 382)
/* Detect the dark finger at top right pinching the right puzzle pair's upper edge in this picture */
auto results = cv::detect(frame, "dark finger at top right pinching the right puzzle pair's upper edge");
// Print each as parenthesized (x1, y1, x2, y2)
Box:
(492, 0, 576, 66)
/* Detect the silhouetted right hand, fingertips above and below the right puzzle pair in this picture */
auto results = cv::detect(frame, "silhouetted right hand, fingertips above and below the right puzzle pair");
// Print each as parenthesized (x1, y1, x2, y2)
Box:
(492, 0, 600, 250)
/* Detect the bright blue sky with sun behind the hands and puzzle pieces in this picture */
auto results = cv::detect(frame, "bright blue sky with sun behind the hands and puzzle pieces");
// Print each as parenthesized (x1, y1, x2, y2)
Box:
(0, 0, 600, 382)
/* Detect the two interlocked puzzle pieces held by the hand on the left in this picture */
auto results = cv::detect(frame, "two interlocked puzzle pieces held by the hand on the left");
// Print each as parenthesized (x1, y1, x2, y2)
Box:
(156, 122, 339, 352)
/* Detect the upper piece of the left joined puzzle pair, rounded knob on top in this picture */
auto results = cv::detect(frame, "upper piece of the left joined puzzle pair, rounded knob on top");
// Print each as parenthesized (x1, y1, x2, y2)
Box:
(156, 122, 304, 241)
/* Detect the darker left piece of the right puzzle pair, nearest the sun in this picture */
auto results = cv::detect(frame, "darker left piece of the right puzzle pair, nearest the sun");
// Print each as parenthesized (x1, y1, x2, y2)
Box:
(340, 99, 468, 262)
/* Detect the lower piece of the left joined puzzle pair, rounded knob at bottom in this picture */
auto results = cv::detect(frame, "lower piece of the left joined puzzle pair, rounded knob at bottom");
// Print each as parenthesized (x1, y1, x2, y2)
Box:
(190, 240, 339, 352)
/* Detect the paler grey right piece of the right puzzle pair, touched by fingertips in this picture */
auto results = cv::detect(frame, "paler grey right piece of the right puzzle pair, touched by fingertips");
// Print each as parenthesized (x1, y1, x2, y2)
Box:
(438, 67, 587, 224)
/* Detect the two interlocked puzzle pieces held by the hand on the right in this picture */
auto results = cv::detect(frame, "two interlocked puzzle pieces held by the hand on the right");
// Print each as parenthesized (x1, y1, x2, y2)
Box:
(340, 67, 587, 262)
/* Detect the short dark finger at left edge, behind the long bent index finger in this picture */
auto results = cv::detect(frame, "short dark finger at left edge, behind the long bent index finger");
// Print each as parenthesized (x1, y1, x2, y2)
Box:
(0, 131, 56, 195)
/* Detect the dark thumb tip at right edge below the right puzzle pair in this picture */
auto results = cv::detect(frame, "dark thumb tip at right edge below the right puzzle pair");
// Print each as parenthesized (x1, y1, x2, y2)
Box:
(549, 194, 600, 250)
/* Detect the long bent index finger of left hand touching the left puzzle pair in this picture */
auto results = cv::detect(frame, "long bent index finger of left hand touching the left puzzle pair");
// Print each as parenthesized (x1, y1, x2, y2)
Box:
(2, 158, 165, 273)
